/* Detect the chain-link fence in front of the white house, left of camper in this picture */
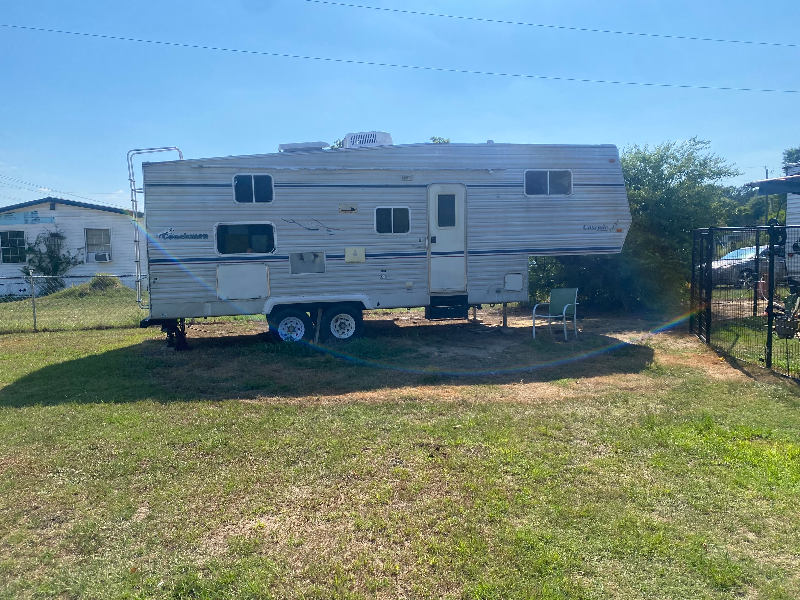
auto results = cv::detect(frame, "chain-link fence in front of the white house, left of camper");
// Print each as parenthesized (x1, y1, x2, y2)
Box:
(0, 275, 147, 334)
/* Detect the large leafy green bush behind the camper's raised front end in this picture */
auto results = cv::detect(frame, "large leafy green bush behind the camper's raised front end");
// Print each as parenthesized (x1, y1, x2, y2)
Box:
(530, 138, 739, 310)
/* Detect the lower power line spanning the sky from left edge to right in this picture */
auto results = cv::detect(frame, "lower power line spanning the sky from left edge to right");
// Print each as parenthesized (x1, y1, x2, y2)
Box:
(0, 23, 800, 94)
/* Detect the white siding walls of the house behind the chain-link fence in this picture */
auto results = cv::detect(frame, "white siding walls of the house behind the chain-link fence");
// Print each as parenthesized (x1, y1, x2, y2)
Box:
(0, 200, 146, 295)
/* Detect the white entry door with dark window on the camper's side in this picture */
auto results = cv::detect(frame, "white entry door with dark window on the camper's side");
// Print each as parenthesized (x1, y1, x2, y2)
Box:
(428, 183, 467, 293)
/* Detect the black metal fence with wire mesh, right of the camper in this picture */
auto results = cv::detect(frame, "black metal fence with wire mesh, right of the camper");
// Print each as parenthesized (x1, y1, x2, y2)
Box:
(690, 226, 800, 377)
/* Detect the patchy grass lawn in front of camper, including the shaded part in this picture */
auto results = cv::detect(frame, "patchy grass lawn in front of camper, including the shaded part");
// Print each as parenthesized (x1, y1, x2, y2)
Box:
(0, 311, 800, 599)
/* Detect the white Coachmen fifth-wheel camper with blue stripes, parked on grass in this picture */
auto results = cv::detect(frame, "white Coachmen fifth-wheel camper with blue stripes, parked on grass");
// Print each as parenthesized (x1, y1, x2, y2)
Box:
(129, 132, 631, 341)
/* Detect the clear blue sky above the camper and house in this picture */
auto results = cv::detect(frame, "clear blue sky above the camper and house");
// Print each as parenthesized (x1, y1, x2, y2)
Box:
(0, 0, 800, 206)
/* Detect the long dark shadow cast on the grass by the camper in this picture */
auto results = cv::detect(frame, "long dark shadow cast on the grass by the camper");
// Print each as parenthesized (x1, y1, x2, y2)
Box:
(0, 321, 653, 406)
